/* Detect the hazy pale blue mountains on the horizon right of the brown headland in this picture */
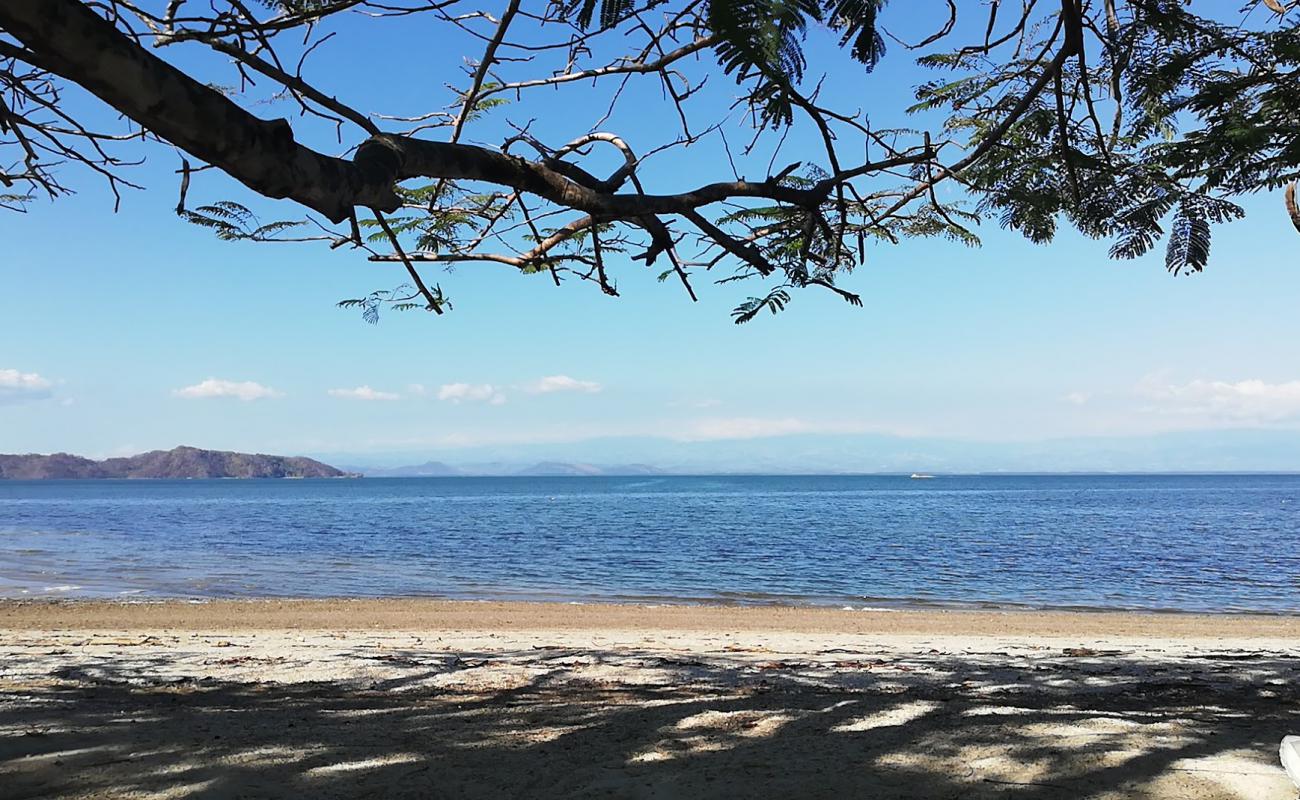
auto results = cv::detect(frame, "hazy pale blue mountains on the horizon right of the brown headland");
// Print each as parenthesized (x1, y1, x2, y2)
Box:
(322, 428, 1300, 477)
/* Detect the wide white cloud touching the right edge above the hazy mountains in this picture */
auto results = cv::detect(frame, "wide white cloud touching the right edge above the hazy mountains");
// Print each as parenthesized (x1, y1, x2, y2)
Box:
(1138, 377, 1300, 424)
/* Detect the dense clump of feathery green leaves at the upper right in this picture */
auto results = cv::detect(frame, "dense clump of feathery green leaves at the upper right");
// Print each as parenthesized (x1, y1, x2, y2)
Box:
(911, 0, 1300, 282)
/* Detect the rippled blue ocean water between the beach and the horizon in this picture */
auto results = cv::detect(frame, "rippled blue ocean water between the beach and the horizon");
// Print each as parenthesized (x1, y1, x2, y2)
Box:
(0, 475, 1300, 613)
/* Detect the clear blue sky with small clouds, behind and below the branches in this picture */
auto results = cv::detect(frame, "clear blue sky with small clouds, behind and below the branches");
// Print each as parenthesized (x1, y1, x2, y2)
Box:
(0, 4, 1300, 470)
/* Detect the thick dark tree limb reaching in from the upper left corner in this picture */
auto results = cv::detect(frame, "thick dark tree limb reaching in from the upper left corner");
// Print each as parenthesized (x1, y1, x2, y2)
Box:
(0, 0, 822, 228)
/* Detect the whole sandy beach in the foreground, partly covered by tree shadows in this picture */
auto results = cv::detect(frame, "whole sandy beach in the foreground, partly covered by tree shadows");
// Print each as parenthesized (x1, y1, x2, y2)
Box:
(0, 600, 1300, 800)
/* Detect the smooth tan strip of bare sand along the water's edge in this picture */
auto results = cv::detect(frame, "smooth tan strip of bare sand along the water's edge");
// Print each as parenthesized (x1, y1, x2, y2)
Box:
(0, 598, 1300, 641)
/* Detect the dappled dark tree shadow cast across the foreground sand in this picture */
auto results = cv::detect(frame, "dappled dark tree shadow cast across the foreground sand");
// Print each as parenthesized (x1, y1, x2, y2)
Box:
(0, 650, 1300, 800)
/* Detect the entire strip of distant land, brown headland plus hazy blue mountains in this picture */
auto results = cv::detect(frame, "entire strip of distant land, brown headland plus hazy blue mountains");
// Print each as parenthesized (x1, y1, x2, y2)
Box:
(15, 428, 1300, 479)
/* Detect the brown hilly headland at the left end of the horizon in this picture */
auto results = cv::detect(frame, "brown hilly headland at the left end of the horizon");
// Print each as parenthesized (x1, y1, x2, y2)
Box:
(0, 446, 348, 480)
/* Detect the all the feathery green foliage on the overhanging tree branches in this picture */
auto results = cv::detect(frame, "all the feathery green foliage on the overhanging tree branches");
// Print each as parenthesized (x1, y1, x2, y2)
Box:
(180, 0, 1300, 324)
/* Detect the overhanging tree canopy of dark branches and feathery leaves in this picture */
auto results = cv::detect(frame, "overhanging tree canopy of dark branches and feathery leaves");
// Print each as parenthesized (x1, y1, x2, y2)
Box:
(0, 0, 1300, 323)
